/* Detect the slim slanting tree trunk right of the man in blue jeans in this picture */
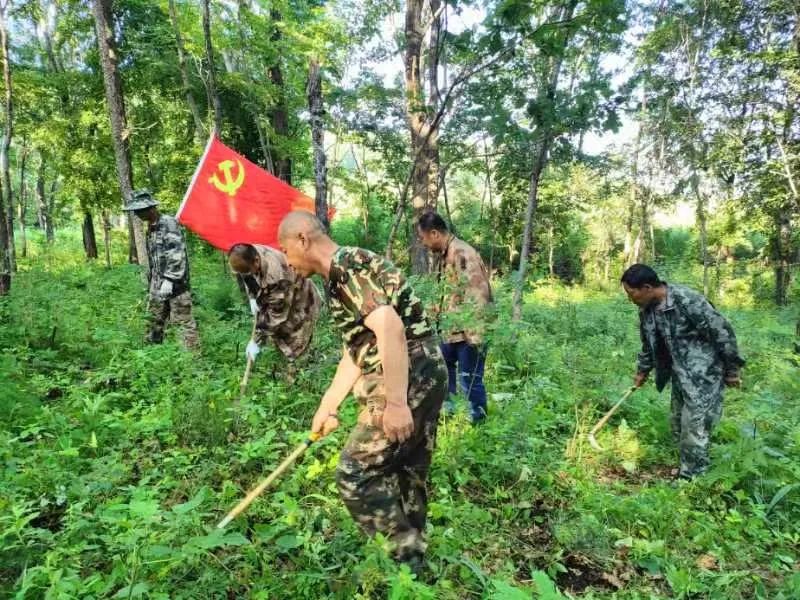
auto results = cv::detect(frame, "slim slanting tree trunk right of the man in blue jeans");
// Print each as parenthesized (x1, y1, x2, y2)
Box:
(511, 0, 578, 322)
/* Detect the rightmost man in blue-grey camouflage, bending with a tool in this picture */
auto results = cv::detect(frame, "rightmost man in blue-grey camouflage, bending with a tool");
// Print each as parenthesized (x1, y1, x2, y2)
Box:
(622, 264, 744, 479)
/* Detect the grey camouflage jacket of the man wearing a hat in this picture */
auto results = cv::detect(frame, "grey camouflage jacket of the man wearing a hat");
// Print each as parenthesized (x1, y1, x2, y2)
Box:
(147, 215, 189, 297)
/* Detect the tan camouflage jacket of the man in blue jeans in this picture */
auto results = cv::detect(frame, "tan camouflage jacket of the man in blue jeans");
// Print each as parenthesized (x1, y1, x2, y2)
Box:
(436, 236, 492, 345)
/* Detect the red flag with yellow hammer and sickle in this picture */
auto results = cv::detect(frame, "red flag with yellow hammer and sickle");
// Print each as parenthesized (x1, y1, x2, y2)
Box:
(175, 136, 314, 252)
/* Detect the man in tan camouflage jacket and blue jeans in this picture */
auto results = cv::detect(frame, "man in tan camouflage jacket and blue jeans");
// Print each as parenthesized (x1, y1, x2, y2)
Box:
(418, 212, 492, 424)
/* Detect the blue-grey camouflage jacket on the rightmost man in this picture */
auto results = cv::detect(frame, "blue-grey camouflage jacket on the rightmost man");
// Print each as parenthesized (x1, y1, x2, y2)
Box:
(638, 285, 744, 394)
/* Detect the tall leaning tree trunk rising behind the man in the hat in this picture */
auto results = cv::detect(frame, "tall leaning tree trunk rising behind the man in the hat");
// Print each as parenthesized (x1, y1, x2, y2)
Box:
(92, 0, 147, 269)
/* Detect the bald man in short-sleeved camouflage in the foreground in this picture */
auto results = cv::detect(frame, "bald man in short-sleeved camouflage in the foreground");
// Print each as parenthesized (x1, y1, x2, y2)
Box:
(279, 211, 447, 571)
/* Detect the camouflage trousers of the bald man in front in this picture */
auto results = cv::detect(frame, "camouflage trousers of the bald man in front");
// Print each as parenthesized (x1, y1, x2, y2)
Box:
(336, 337, 447, 561)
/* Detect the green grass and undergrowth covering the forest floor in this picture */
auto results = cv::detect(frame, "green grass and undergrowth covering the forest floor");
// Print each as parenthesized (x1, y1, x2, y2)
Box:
(0, 232, 800, 600)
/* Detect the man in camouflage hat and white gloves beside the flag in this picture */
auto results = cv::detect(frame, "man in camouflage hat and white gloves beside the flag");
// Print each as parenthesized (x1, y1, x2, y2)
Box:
(125, 190, 199, 349)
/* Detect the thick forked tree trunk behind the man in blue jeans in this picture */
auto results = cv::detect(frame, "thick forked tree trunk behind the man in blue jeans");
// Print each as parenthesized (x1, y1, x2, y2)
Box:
(405, 0, 442, 274)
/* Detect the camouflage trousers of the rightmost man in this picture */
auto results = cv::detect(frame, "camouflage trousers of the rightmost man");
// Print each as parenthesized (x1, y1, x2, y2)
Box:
(671, 374, 722, 478)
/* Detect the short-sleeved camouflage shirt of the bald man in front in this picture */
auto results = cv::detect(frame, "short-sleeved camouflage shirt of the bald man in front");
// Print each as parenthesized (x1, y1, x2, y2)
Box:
(327, 246, 433, 374)
